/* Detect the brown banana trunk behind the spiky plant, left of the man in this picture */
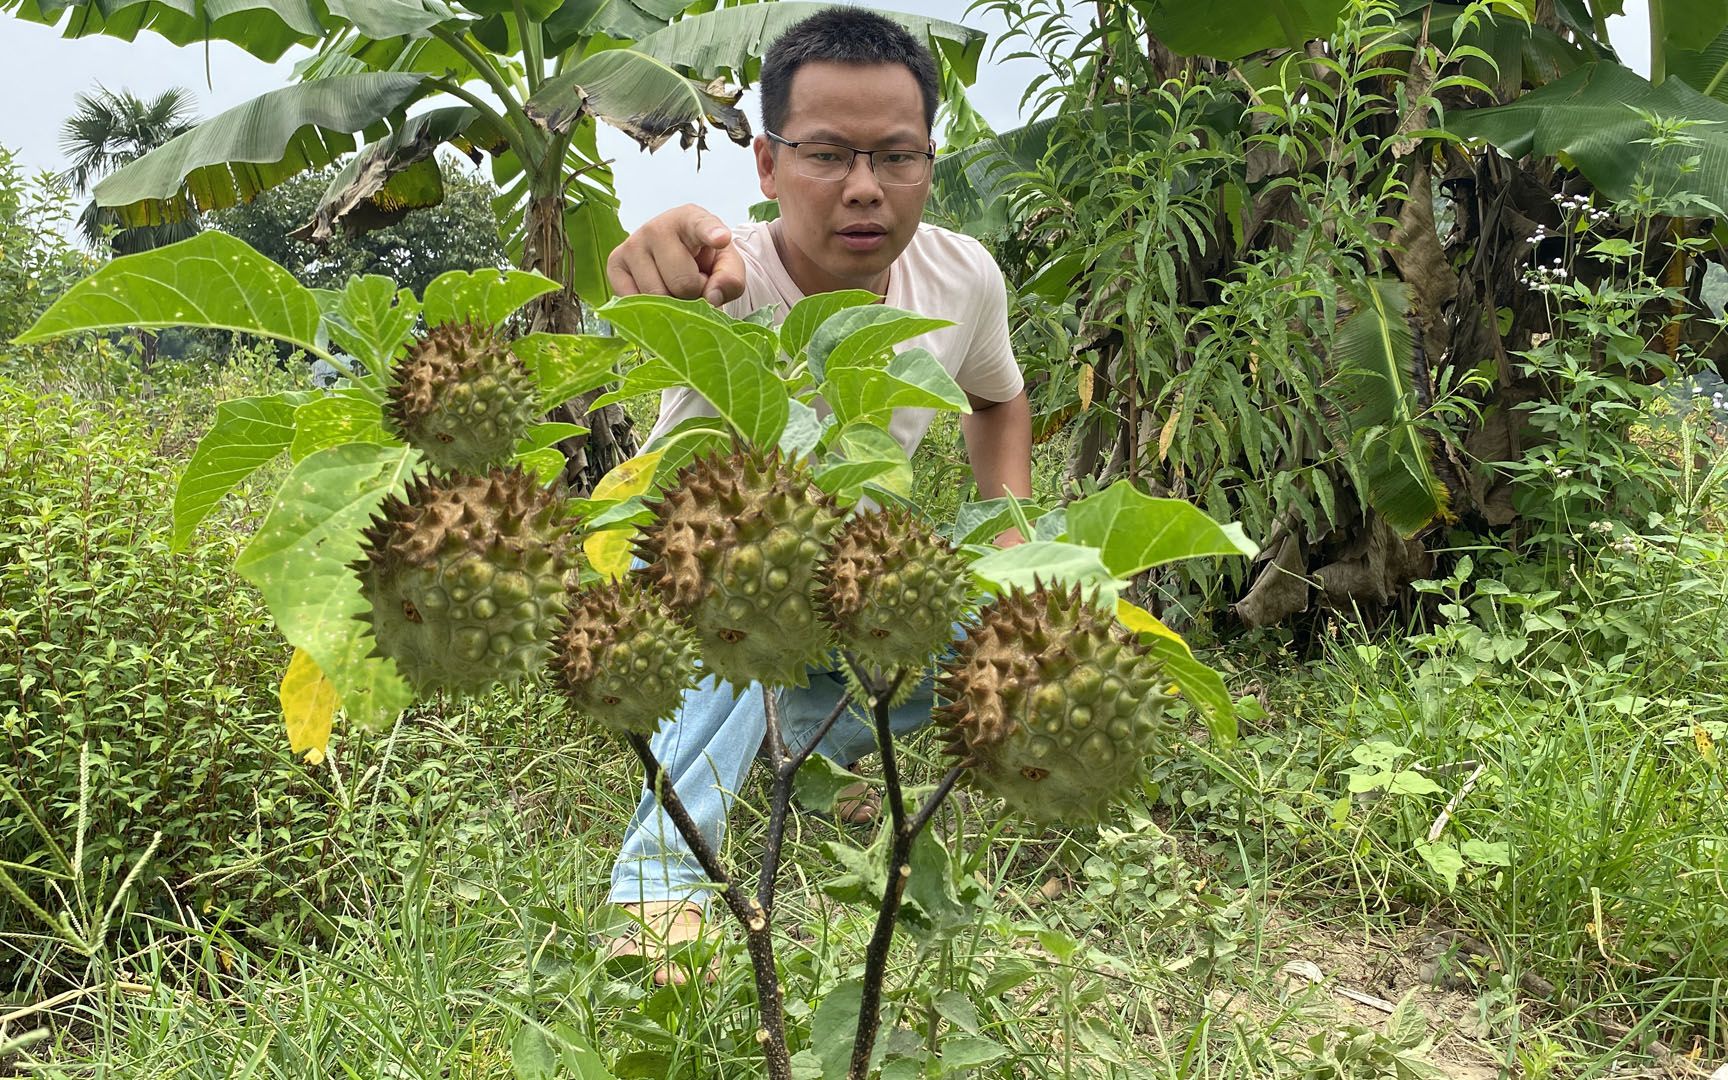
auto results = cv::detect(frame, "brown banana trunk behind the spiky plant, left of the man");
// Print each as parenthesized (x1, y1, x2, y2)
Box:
(522, 192, 636, 496)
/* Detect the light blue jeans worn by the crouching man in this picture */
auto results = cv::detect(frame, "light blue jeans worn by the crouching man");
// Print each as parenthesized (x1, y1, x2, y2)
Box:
(608, 669, 931, 907)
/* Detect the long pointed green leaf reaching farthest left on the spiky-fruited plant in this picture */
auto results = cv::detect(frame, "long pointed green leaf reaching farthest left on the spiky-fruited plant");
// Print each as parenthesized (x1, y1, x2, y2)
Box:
(17, 232, 320, 349)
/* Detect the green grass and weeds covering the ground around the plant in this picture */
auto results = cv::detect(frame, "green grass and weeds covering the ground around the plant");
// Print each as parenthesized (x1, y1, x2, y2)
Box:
(0, 349, 1728, 1080)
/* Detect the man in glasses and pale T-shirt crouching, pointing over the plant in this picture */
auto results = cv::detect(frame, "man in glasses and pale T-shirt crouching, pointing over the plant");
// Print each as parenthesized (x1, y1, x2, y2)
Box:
(607, 9, 1032, 983)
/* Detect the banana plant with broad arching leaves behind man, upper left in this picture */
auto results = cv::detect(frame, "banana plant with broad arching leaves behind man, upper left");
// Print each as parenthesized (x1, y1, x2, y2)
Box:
(0, 0, 983, 489)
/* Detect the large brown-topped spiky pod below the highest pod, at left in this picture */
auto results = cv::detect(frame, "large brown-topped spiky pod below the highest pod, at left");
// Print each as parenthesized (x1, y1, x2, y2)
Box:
(354, 468, 574, 693)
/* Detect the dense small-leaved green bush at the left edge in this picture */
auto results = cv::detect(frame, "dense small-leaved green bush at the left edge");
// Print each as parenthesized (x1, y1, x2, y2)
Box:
(0, 354, 328, 985)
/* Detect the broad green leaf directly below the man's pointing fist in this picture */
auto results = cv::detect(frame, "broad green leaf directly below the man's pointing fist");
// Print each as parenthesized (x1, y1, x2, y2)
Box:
(600, 295, 790, 446)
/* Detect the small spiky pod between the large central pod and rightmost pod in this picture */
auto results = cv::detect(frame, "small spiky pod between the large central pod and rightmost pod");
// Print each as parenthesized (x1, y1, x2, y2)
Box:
(817, 508, 971, 672)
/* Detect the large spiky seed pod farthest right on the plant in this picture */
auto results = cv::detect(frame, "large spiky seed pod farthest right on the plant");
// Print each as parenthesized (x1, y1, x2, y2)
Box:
(940, 586, 1170, 824)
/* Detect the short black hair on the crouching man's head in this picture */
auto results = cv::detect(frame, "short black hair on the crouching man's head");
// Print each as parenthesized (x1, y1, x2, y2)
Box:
(760, 7, 938, 131)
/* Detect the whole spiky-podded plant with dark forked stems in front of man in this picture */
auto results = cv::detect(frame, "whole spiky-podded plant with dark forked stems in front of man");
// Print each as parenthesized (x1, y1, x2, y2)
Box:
(19, 233, 1253, 1080)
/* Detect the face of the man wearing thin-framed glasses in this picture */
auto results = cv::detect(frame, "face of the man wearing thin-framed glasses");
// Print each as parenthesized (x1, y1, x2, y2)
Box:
(755, 62, 930, 294)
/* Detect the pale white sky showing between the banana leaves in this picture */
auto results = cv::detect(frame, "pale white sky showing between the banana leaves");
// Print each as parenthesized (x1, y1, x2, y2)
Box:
(0, 0, 1650, 228)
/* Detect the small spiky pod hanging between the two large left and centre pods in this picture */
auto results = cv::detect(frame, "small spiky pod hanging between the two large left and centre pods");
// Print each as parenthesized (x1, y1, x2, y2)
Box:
(553, 577, 698, 734)
